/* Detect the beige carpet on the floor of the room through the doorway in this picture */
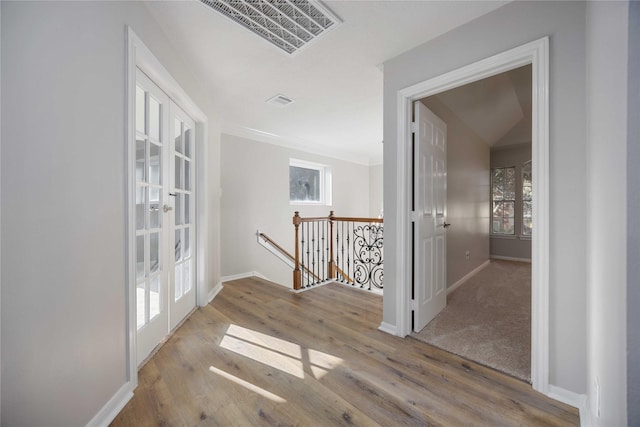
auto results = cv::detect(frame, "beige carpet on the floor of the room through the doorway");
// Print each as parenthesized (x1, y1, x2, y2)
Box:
(412, 260, 531, 382)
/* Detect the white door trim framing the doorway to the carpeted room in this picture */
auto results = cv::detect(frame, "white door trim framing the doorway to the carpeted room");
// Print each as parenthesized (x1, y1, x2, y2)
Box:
(394, 37, 549, 394)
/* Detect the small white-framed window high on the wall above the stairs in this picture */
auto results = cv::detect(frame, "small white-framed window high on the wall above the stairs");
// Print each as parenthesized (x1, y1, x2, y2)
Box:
(289, 159, 331, 205)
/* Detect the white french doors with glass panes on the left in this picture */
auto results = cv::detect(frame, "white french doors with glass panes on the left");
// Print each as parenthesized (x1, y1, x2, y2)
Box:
(132, 70, 195, 365)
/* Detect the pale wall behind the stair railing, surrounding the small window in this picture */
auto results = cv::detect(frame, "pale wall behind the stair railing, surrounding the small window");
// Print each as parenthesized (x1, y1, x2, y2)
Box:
(221, 134, 369, 286)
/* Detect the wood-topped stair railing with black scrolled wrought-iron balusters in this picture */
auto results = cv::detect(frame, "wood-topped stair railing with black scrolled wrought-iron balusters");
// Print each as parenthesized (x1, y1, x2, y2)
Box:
(293, 211, 384, 290)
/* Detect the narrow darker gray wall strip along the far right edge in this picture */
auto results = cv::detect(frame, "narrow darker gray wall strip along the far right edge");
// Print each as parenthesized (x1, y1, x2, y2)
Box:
(627, 1, 640, 426)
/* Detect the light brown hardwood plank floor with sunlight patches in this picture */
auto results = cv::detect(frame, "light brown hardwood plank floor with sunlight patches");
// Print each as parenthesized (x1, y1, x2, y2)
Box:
(112, 278, 579, 426)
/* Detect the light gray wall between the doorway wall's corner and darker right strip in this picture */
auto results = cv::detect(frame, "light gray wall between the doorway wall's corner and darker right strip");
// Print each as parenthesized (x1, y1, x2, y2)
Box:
(586, 2, 639, 426)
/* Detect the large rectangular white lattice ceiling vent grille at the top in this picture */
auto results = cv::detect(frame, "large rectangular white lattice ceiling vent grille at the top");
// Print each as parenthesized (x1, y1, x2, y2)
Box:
(200, 0, 340, 54)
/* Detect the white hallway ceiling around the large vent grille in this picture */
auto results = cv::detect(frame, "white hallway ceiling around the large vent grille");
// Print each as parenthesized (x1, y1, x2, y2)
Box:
(147, 0, 507, 164)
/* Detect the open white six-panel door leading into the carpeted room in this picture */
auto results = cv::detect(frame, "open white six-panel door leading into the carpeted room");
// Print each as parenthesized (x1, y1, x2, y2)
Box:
(413, 101, 447, 331)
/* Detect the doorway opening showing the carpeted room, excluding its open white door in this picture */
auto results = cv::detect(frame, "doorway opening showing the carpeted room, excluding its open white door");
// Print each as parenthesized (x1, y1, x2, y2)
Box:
(412, 65, 533, 382)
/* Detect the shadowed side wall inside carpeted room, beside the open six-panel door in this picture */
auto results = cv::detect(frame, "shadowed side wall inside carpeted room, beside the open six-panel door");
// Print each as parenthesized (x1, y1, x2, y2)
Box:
(421, 97, 489, 286)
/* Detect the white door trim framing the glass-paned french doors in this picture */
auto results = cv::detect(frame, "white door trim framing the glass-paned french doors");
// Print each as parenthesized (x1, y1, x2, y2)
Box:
(125, 26, 209, 390)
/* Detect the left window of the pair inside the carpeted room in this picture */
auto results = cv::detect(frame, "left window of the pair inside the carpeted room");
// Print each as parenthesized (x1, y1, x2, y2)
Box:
(491, 167, 516, 234)
